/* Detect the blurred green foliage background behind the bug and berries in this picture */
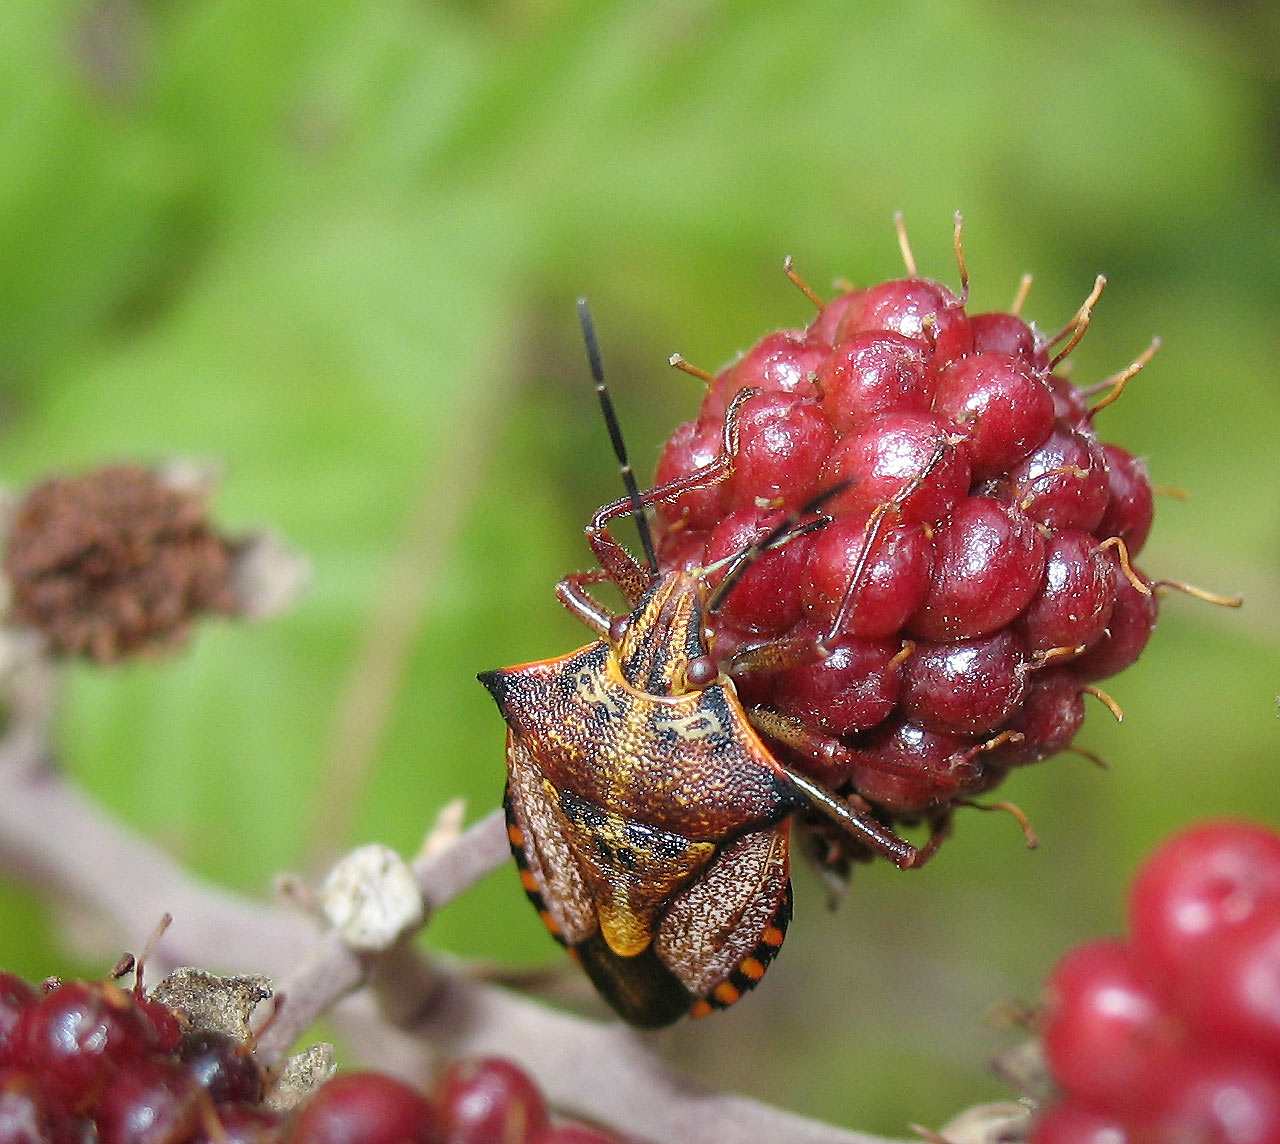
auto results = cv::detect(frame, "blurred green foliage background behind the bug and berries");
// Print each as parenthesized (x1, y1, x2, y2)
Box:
(0, 0, 1280, 1134)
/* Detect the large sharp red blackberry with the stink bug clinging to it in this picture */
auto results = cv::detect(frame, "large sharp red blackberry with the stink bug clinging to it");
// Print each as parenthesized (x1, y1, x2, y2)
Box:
(657, 252, 1157, 818)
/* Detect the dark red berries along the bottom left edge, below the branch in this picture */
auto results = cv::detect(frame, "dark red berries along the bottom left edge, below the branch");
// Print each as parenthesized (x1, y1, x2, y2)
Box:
(0, 973, 618, 1144)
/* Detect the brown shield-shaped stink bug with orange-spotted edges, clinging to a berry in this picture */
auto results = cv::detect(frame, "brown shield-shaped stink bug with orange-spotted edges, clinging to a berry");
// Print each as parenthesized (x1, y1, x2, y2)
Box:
(479, 302, 940, 1028)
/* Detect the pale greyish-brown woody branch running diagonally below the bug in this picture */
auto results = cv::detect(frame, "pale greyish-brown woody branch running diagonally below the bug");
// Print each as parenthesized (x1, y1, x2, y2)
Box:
(0, 658, 952, 1144)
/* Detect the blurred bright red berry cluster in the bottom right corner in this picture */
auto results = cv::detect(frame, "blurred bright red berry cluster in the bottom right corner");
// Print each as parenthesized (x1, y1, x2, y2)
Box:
(1032, 823, 1280, 1144)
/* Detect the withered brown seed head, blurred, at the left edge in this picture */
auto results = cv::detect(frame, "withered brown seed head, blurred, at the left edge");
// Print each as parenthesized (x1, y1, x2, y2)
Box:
(4, 465, 236, 663)
